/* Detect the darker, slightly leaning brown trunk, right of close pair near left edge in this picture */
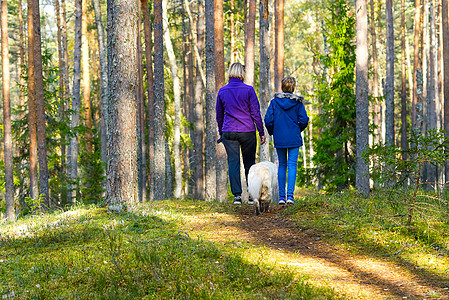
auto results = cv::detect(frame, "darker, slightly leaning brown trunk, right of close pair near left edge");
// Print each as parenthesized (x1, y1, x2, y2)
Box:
(33, 1, 50, 208)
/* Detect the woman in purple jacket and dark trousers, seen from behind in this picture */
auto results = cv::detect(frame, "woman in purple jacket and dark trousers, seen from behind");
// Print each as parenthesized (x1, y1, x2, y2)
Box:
(216, 63, 265, 204)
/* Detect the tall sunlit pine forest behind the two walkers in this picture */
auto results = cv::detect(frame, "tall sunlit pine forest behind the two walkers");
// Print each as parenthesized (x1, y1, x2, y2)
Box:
(0, 0, 449, 221)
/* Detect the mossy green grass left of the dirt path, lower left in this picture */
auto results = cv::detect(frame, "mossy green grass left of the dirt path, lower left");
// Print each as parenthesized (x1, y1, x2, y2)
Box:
(0, 201, 337, 299)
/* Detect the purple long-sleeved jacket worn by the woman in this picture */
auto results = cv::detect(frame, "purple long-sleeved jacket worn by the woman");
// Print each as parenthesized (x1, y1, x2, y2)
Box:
(216, 78, 264, 136)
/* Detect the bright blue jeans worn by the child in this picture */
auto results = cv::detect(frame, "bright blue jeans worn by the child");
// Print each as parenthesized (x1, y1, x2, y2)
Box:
(276, 148, 299, 197)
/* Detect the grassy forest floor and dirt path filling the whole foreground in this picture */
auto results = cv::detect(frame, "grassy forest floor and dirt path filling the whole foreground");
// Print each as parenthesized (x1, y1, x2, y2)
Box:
(0, 199, 449, 300)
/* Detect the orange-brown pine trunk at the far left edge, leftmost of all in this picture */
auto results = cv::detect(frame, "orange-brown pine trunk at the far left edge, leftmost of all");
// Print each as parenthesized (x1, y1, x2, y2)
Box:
(0, 0, 16, 221)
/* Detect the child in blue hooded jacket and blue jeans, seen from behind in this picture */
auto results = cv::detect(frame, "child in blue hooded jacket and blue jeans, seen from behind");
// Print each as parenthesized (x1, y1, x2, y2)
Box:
(265, 77, 309, 205)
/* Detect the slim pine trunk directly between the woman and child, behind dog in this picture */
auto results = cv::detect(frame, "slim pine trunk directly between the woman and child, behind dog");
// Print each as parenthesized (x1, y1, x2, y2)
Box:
(259, 0, 271, 161)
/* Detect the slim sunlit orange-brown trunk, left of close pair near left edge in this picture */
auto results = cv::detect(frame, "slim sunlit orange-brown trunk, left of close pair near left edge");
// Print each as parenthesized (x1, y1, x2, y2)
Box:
(27, 0, 39, 204)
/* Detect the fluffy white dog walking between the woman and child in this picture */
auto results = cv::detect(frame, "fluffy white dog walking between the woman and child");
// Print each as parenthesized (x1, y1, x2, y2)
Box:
(248, 161, 279, 216)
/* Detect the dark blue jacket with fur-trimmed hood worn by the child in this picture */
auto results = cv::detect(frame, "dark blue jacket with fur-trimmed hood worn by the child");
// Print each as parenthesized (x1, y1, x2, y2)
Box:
(264, 93, 309, 148)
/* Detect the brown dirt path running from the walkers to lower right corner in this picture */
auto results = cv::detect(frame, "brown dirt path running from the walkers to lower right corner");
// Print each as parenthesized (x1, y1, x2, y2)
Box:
(181, 205, 449, 299)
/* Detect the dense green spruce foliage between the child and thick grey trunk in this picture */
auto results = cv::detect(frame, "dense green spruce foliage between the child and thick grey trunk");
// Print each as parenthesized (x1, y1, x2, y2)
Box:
(313, 0, 355, 190)
